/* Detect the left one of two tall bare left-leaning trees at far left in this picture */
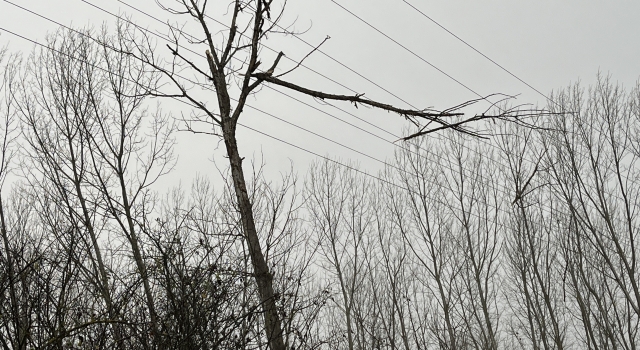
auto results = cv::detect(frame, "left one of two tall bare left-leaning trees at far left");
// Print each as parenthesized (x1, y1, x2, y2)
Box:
(15, 32, 129, 348)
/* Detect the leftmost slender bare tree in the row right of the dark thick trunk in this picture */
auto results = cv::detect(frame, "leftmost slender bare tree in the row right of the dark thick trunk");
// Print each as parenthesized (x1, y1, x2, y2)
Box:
(306, 161, 374, 349)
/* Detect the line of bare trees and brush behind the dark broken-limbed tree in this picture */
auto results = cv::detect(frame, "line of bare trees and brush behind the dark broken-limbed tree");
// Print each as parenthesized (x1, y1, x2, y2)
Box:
(0, 32, 640, 350)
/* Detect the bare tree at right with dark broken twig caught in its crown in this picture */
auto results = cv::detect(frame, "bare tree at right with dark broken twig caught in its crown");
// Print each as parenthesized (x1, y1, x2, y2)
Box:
(499, 121, 568, 349)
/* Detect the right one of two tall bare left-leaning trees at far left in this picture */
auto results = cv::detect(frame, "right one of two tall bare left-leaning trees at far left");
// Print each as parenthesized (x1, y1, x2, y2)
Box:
(87, 28, 174, 348)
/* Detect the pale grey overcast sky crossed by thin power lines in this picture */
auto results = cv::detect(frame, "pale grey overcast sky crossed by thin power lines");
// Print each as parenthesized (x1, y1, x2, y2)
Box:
(0, 0, 640, 191)
